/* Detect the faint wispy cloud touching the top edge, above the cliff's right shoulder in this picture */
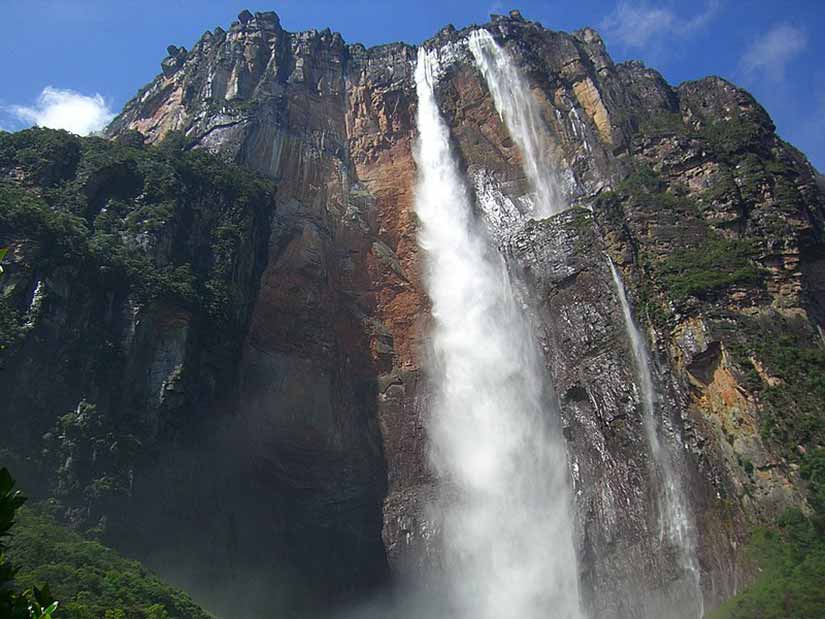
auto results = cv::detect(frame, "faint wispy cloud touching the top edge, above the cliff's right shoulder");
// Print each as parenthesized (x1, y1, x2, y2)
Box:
(601, 0, 721, 48)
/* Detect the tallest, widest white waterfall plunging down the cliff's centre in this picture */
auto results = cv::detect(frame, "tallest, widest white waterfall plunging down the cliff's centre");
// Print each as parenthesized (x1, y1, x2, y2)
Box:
(415, 49, 580, 619)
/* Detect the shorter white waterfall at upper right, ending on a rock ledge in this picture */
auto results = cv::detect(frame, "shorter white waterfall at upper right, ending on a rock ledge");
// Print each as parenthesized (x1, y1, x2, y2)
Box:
(468, 29, 565, 217)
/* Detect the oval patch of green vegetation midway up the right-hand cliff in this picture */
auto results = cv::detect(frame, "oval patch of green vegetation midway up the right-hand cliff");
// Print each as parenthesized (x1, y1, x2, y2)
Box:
(657, 237, 763, 301)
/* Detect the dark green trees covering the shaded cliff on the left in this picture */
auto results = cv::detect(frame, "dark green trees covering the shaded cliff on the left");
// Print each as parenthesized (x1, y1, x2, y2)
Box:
(0, 128, 274, 528)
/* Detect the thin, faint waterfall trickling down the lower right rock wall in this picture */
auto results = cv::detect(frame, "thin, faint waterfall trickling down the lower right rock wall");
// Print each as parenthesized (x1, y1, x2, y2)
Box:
(608, 258, 704, 618)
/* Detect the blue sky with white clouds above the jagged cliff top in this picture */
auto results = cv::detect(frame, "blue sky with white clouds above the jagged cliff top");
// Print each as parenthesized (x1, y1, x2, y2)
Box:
(0, 0, 825, 171)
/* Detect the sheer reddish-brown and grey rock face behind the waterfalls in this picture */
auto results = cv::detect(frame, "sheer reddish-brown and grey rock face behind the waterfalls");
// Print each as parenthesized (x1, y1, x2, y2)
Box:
(90, 7, 825, 617)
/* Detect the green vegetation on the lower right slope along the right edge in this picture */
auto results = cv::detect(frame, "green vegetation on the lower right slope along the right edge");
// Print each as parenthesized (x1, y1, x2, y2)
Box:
(708, 312, 825, 619)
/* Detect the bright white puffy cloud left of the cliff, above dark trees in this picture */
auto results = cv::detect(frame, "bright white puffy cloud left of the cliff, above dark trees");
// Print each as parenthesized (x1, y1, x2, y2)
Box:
(7, 86, 115, 135)
